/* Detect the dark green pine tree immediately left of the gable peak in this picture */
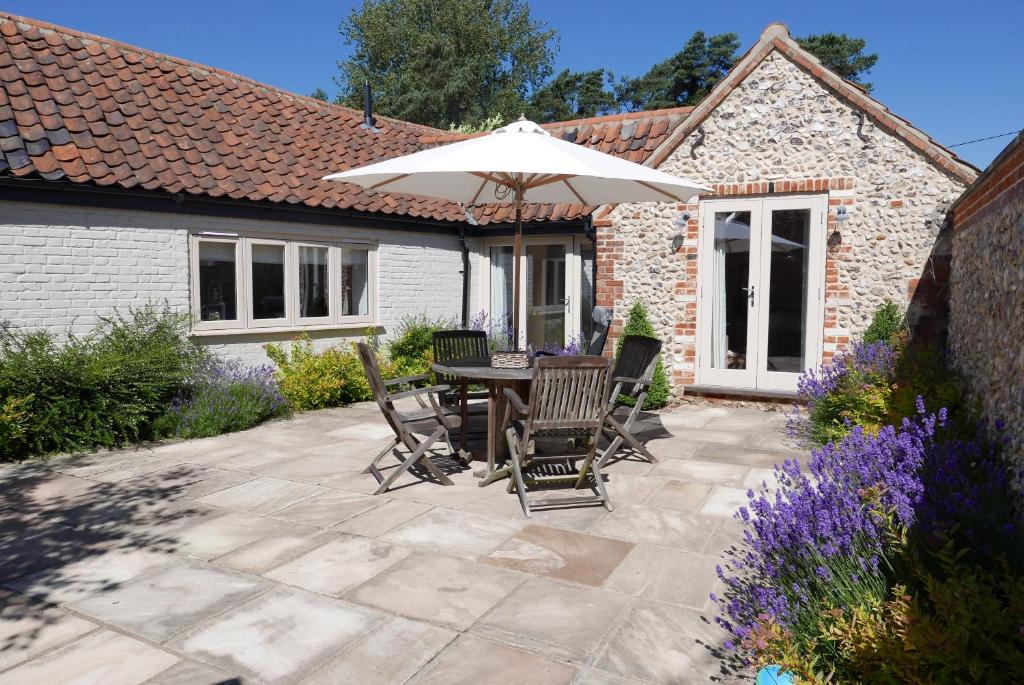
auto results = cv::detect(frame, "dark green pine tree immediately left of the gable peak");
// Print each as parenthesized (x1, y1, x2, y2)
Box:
(615, 31, 739, 112)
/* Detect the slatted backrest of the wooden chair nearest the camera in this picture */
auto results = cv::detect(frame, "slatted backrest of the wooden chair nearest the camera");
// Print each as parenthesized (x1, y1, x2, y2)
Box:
(526, 356, 610, 432)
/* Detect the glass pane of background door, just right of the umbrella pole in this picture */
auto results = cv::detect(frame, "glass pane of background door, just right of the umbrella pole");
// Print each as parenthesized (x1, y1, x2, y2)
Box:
(525, 245, 565, 349)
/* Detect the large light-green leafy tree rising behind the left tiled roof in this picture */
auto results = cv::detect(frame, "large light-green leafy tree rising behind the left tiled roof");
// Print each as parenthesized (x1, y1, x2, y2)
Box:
(336, 0, 557, 128)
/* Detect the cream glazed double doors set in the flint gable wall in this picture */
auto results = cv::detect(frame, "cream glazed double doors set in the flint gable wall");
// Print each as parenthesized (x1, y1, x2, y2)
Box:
(697, 196, 827, 391)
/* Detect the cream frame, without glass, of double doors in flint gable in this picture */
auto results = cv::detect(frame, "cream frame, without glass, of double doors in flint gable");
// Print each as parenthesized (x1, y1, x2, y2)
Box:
(694, 194, 828, 391)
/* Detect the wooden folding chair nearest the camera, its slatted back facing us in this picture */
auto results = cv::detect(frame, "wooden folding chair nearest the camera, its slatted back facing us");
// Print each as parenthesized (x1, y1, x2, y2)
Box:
(503, 356, 611, 517)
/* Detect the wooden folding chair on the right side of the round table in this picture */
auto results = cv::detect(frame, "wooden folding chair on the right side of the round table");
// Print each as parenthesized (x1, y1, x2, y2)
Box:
(599, 336, 662, 467)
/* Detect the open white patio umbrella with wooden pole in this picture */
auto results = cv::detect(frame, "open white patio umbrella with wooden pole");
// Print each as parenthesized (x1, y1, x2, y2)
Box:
(324, 117, 708, 348)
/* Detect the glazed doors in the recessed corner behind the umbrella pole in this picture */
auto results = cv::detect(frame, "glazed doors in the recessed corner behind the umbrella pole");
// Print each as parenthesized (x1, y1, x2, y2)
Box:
(481, 237, 580, 349)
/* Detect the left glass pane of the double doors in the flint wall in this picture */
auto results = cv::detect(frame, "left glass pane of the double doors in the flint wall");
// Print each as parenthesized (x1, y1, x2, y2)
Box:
(711, 212, 751, 369)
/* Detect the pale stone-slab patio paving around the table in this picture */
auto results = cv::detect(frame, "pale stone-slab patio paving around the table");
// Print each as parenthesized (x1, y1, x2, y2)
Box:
(0, 405, 794, 685)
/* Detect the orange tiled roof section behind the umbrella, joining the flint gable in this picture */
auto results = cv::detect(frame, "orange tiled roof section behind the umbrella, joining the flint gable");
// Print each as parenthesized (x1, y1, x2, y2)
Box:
(420, 106, 693, 224)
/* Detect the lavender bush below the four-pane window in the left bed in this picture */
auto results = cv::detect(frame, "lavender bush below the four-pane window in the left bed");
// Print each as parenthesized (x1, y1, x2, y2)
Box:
(157, 359, 289, 438)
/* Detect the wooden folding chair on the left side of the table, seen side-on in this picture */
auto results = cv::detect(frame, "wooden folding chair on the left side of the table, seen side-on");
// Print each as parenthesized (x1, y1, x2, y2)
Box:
(357, 342, 460, 495)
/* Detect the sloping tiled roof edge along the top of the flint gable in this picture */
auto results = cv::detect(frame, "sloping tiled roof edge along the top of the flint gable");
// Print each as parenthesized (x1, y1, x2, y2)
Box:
(646, 24, 979, 183)
